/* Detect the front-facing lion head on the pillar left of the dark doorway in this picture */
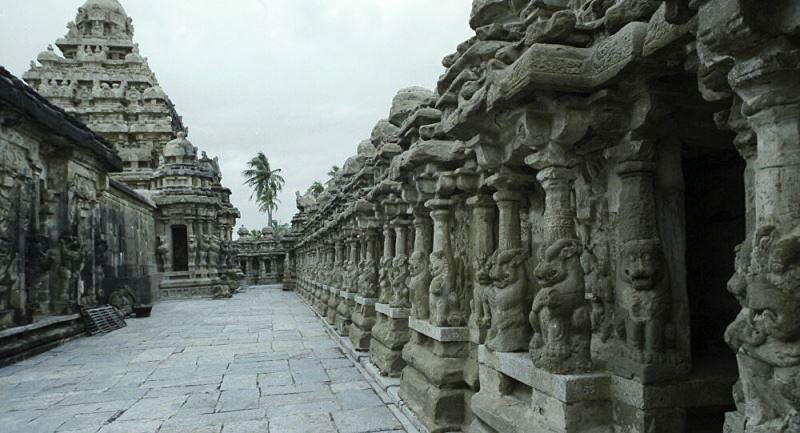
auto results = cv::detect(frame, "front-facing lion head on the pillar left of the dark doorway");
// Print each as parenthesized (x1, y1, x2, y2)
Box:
(619, 239, 664, 290)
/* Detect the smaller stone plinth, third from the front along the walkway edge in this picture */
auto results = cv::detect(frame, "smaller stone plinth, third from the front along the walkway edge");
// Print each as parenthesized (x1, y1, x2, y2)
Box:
(369, 304, 410, 377)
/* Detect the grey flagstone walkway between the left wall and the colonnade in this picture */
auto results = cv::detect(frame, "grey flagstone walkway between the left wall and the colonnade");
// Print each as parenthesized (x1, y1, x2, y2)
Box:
(0, 286, 405, 433)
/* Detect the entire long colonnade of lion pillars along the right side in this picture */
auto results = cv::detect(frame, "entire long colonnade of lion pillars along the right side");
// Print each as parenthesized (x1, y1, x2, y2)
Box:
(288, 0, 800, 433)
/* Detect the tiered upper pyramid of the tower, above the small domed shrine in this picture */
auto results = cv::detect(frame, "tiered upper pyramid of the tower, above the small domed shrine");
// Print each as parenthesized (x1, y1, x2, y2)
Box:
(23, 0, 185, 190)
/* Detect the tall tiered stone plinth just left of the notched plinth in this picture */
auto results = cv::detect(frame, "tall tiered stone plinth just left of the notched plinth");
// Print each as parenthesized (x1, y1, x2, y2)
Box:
(400, 317, 472, 433)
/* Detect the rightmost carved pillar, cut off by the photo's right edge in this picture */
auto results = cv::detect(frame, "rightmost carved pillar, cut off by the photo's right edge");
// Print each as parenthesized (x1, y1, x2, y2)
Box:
(698, 6, 800, 426)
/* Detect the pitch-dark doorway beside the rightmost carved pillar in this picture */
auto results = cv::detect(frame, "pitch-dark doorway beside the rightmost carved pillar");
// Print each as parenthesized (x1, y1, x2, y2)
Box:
(683, 143, 746, 433)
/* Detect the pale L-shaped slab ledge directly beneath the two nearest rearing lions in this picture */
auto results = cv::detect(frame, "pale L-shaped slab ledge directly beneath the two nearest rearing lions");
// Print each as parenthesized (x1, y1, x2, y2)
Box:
(478, 345, 611, 403)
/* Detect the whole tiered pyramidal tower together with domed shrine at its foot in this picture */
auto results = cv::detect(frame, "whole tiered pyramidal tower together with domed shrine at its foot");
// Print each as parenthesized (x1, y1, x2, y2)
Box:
(23, 0, 239, 298)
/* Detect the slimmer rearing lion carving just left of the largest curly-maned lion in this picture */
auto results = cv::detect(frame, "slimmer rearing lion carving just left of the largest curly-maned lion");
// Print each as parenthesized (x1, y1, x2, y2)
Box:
(486, 248, 531, 352)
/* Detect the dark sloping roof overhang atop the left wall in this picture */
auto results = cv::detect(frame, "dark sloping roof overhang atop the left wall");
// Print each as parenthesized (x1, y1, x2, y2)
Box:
(0, 66, 122, 172)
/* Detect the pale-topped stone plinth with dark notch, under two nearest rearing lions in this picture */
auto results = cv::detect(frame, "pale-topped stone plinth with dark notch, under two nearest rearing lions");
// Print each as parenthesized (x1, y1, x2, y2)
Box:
(470, 345, 613, 433)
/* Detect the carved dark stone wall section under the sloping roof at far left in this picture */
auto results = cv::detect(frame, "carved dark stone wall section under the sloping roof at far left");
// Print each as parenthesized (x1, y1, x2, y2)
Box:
(0, 75, 118, 327)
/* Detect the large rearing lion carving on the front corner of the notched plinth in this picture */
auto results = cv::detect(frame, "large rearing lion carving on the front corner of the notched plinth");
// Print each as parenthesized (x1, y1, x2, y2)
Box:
(530, 239, 591, 374)
